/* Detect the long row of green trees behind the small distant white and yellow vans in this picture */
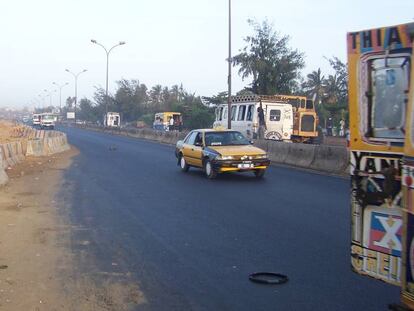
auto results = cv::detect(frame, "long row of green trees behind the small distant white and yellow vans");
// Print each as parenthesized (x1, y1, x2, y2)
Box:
(77, 79, 214, 129)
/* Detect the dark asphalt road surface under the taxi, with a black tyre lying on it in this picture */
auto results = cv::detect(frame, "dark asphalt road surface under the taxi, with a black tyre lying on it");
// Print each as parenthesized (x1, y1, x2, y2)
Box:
(60, 128, 399, 311)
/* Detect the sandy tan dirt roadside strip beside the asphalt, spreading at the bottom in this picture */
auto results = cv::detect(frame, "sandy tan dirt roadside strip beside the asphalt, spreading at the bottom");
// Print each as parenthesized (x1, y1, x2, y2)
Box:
(0, 148, 146, 311)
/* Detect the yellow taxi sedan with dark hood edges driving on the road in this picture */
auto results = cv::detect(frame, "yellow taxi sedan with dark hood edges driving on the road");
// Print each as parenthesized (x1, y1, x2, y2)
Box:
(175, 129, 270, 179)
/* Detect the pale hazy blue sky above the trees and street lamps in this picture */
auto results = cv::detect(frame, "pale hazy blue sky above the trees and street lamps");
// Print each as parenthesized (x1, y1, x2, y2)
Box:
(0, 0, 414, 108)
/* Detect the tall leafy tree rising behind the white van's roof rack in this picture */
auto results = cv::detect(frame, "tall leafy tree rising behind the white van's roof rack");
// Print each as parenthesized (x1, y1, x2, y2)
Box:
(232, 20, 305, 95)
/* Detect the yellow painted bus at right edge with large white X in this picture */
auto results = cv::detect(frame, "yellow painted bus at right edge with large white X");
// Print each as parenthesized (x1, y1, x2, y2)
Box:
(347, 23, 414, 307)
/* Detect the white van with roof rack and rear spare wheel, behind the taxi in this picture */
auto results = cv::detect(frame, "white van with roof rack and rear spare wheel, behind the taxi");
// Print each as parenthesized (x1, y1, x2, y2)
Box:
(213, 95, 293, 140)
